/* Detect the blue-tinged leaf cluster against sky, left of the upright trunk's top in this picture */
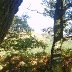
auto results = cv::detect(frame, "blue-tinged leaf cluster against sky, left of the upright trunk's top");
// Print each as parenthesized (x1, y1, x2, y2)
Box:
(42, 0, 56, 18)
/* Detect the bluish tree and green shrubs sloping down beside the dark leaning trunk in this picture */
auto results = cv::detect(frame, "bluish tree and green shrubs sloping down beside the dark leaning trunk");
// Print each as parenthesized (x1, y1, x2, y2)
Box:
(0, 15, 47, 50)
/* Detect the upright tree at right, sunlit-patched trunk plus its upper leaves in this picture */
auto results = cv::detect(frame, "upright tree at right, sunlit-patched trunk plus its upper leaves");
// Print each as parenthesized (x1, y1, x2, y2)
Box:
(44, 0, 72, 72)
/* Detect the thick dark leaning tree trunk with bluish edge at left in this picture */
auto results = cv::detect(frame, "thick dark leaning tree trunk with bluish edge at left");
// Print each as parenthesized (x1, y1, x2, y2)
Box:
(0, 0, 22, 44)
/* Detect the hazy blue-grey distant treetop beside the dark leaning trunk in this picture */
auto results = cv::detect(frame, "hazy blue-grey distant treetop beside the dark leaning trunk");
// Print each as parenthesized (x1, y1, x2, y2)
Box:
(11, 15, 32, 32)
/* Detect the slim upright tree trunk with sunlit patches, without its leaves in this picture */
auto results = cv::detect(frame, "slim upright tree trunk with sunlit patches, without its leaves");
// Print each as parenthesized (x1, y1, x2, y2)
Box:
(50, 0, 63, 72)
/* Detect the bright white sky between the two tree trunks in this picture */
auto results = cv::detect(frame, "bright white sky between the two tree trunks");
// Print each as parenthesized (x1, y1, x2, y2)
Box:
(16, 0, 54, 33)
